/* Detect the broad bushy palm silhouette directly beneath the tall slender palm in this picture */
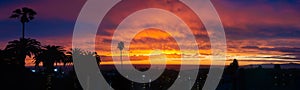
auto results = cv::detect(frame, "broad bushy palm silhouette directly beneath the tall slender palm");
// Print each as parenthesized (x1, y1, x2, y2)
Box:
(5, 38, 41, 66)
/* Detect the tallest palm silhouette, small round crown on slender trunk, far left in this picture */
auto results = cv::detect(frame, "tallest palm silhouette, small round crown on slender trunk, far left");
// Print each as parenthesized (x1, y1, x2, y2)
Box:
(9, 7, 37, 38)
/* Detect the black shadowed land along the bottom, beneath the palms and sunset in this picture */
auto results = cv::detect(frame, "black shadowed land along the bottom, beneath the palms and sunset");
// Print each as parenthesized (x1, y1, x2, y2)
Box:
(0, 65, 300, 90)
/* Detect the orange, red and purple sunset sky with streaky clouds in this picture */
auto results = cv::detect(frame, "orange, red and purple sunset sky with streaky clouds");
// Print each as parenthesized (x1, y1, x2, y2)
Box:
(0, 0, 300, 65)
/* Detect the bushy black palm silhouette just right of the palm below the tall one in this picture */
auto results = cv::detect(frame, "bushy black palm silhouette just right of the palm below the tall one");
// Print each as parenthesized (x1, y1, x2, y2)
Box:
(34, 45, 66, 72)
